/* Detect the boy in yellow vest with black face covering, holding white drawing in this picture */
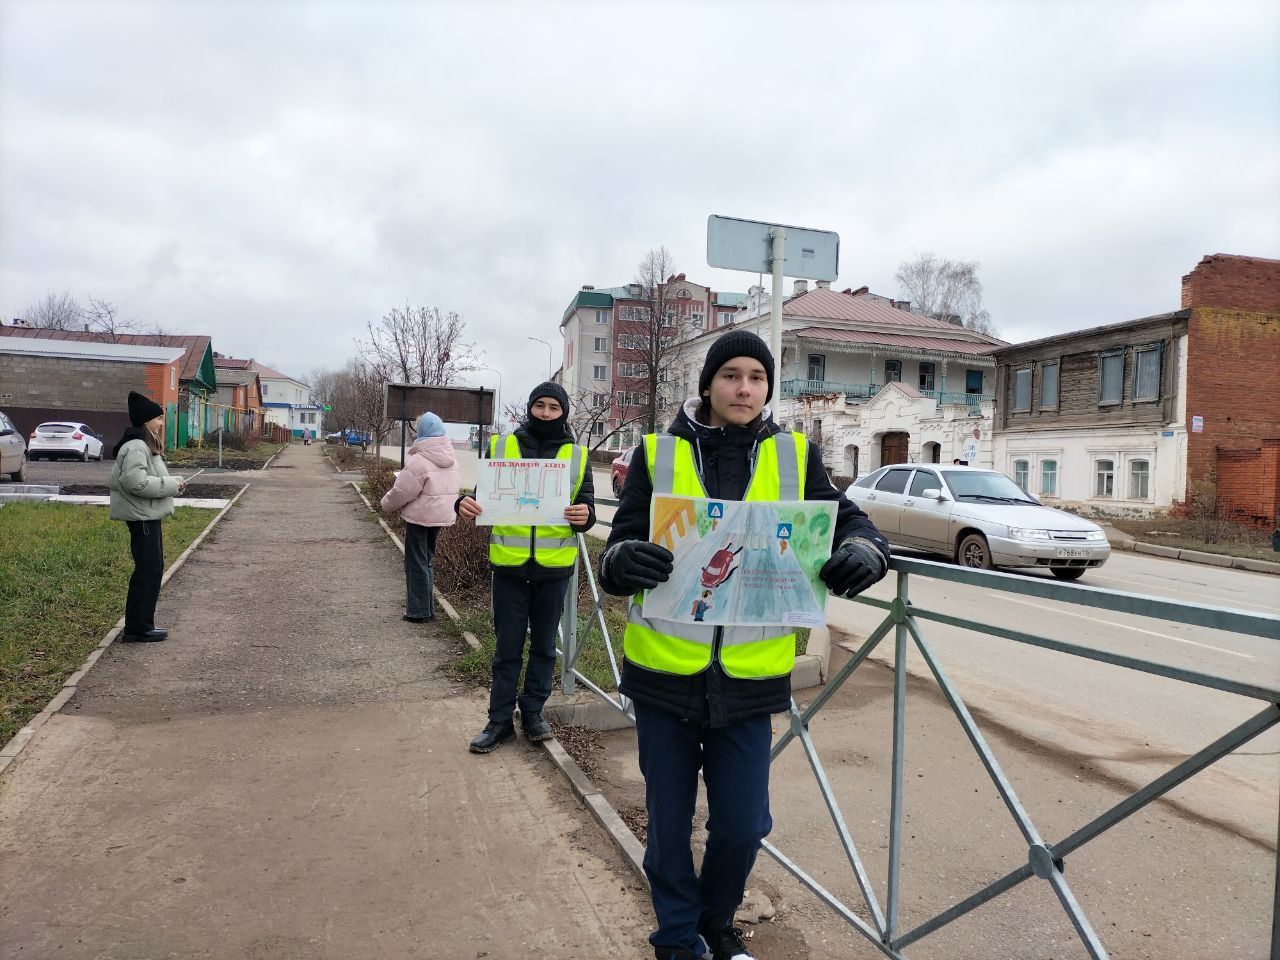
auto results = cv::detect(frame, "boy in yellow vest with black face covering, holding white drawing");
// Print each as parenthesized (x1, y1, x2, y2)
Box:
(454, 383, 595, 754)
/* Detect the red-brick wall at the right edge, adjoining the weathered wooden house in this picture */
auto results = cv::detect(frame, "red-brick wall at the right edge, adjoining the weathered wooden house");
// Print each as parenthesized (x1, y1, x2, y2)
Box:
(1183, 253, 1280, 516)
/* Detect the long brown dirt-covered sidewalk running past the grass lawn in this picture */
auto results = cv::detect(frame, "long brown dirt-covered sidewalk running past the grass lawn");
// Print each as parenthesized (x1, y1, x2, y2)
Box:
(0, 445, 650, 959)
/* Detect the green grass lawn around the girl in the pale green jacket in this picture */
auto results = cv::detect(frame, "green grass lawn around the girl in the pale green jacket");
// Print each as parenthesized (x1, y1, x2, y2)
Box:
(0, 502, 218, 744)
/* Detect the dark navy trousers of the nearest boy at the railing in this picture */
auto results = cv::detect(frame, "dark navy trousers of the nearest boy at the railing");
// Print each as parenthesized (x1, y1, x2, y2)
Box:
(635, 703, 773, 956)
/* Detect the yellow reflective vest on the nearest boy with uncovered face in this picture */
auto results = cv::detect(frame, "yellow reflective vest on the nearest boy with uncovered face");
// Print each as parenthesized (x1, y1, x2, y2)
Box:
(622, 433, 809, 680)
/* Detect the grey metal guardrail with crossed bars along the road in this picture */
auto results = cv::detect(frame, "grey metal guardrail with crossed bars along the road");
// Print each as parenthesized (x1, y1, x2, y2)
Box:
(559, 499, 1280, 960)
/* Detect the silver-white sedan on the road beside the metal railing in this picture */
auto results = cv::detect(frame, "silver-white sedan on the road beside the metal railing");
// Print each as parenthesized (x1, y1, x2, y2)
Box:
(849, 463, 1111, 580)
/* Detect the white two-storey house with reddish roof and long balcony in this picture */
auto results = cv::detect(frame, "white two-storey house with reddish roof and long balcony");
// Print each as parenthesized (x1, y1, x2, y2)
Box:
(667, 280, 1004, 480)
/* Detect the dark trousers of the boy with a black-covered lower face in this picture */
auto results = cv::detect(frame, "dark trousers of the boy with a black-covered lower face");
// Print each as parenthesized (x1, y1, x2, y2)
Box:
(489, 573, 568, 723)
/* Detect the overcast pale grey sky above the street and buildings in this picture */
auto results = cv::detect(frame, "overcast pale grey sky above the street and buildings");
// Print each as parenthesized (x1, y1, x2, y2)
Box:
(0, 0, 1280, 409)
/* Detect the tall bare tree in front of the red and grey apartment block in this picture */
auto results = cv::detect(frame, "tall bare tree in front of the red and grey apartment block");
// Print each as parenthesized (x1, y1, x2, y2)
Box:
(612, 247, 695, 433)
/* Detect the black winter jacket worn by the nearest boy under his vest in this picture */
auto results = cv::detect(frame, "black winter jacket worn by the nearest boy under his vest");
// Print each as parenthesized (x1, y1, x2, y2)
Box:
(600, 398, 890, 727)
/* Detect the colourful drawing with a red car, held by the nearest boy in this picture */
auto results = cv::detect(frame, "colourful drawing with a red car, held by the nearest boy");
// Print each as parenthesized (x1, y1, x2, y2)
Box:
(644, 494, 836, 627)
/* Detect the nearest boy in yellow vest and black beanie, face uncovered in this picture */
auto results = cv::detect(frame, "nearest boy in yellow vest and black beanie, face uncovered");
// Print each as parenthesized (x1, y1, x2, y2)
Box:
(600, 330, 890, 960)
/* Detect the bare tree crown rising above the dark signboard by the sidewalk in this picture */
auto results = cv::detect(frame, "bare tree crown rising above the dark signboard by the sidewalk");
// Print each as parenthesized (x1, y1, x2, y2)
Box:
(357, 303, 483, 387)
